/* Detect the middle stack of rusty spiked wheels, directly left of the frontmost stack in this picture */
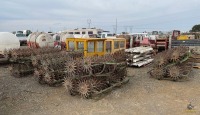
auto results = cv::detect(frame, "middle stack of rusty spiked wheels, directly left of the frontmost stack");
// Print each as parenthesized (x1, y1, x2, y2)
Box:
(32, 51, 75, 86)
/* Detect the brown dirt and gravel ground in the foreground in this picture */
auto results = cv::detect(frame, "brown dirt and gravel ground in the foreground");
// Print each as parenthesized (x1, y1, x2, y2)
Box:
(0, 65, 200, 115)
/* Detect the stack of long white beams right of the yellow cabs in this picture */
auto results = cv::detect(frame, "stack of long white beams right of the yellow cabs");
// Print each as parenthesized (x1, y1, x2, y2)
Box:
(125, 47, 154, 67)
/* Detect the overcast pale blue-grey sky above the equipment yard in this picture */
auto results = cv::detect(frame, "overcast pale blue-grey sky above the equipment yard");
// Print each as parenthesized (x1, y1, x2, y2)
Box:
(0, 0, 200, 33)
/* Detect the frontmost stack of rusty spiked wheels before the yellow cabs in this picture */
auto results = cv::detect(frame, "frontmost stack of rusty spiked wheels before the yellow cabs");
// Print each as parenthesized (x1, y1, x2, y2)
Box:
(64, 51, 128, 98)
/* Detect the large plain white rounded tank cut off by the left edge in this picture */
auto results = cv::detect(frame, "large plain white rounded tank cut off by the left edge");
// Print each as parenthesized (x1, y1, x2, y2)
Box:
(0, 32, 20, 55)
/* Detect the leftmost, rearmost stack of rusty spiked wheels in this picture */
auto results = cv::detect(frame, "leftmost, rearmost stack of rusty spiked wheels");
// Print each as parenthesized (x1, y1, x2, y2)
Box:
(4, 48, 60, 77)
